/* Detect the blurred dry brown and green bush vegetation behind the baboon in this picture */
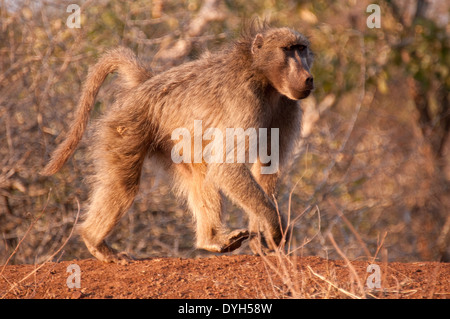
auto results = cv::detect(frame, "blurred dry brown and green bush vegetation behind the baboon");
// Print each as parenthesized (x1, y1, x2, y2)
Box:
(0, 0, 450, 264)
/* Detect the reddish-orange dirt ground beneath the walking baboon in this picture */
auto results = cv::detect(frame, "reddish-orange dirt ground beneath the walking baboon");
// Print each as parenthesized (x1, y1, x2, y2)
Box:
(0, 255, 450, 299)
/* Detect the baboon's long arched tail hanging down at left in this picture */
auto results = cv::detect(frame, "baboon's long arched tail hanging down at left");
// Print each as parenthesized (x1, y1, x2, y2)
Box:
(41, 47, 152, 175)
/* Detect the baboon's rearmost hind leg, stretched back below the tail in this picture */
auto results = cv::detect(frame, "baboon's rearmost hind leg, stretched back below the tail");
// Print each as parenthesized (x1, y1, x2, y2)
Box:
(81, 121, 145, 263)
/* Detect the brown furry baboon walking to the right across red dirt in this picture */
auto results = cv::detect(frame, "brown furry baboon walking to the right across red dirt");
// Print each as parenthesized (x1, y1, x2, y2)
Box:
(42, 23, 314, 262)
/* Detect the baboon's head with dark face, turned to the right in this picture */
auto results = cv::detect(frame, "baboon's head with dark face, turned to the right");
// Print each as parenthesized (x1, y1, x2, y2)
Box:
(251, 28, 314, 100)
